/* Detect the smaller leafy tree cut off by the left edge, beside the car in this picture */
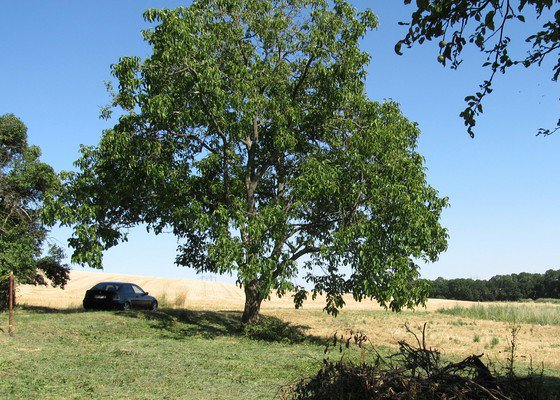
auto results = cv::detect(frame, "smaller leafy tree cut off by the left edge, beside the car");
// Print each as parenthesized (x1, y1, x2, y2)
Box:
(0, 114, 68, 308)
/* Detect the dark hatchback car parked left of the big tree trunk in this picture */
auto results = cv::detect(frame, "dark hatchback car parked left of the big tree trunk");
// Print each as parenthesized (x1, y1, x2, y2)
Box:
(83, 282, 158, 310)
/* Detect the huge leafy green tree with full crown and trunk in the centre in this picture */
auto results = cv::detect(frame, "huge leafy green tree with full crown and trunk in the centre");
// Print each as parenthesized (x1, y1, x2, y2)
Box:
(52, 0, 447, 322)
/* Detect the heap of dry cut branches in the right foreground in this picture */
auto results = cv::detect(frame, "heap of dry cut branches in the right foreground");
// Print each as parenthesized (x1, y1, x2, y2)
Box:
(281, 325, 546, 400)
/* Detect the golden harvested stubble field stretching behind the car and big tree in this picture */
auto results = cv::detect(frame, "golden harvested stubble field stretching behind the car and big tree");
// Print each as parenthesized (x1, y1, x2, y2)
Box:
(18, 271, 560, 370)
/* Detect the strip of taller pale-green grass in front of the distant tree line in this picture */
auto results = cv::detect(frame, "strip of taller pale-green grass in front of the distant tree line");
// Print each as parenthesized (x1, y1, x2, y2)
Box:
(438, 304, 560, 325)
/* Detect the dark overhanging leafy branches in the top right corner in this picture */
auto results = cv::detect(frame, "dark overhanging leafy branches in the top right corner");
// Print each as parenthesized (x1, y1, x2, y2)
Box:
(395, 0, 560, 136)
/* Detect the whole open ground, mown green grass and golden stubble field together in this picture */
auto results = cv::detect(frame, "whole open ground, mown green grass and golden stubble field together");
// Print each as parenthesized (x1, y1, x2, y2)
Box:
(4, 271, 560, 400)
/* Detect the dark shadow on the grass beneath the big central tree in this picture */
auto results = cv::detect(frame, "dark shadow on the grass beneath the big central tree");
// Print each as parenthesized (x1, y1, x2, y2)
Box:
(118, 309, 326, 345)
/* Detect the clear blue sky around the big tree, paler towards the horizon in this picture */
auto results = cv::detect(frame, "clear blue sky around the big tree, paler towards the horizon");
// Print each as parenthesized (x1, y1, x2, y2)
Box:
(0, 0, 560, 278)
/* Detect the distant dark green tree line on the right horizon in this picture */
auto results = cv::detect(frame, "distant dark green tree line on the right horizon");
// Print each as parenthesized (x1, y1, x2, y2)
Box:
(430, 269, 560, 301)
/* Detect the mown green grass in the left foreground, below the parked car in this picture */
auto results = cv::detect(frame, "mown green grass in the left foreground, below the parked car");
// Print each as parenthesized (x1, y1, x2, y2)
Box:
(0, 309, 332, 400)
